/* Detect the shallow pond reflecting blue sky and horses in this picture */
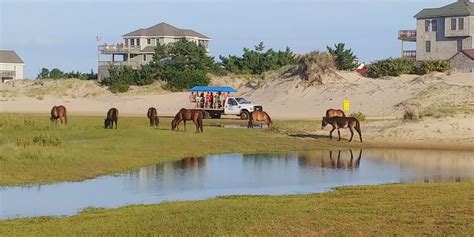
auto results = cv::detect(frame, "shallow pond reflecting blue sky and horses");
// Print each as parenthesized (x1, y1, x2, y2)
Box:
(0, 149, 474, 219)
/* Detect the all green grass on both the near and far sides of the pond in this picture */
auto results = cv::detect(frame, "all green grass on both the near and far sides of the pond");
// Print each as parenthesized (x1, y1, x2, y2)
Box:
(0, 115, 474, 236)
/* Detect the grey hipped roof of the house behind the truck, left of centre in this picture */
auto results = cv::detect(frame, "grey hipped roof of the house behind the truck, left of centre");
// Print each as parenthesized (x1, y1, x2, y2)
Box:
(122, 22, 211, 39)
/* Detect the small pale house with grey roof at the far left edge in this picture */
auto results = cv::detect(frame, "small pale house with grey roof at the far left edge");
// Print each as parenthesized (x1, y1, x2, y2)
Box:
(0, 50, 25, 82)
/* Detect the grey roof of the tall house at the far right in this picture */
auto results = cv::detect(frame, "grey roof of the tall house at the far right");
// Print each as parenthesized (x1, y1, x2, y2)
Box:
(415, 0, 474, 19)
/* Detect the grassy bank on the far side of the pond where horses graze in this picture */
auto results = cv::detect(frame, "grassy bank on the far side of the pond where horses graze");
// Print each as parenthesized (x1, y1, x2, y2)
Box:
(0, 115, 336, 185)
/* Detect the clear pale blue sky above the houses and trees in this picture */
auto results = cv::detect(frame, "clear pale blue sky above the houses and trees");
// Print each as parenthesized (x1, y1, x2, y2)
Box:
(0, 0, 455, 78)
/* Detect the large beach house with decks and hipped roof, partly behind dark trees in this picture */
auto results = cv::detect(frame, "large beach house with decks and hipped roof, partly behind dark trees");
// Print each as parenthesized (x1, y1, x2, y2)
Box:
(98, 22, 211, 80)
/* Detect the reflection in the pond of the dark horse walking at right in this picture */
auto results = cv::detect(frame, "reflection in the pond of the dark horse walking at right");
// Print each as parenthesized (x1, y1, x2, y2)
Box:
(298, 149, 362, 170)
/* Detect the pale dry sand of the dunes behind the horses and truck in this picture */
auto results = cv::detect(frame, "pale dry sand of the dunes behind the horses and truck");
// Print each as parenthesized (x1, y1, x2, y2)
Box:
(0, 72, 474, 149)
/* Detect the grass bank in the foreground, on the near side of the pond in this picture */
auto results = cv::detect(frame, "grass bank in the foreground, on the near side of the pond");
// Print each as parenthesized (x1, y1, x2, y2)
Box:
(0, 183, 474, 236)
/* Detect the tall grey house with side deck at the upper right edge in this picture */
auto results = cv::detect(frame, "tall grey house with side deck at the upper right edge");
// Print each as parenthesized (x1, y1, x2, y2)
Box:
(398, 0, 474, 72)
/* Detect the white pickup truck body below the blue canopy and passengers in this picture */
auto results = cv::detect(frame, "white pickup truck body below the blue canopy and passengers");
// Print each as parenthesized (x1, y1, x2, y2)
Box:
(198, 97, 263, 120)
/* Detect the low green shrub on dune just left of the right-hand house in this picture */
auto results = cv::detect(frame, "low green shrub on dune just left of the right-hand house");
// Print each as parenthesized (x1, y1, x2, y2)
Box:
(367, 58, 415, 78)
